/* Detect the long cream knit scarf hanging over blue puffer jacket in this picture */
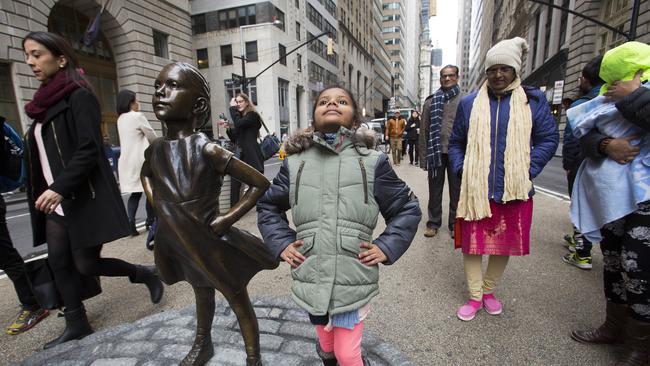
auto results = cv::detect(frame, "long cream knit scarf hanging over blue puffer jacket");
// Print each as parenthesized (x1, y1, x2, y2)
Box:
(456, 76, 533, 221)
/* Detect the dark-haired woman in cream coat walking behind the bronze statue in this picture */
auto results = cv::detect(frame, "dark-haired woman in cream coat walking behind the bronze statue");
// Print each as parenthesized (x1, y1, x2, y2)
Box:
(117, 89, 158, 236)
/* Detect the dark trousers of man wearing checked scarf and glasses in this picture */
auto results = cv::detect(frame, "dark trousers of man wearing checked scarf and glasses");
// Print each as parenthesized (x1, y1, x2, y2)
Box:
(420, 154, 460, 230)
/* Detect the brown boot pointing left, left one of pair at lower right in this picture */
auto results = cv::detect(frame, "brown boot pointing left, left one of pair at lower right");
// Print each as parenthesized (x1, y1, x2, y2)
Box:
(571, 301, 628, 344)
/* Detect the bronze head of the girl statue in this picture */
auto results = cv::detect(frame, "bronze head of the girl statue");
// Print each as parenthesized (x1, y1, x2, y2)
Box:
(151, 64, 198, 122)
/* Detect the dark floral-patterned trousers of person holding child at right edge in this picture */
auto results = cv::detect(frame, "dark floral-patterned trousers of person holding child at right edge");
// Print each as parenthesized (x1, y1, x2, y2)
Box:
(600, 201, 650, 322)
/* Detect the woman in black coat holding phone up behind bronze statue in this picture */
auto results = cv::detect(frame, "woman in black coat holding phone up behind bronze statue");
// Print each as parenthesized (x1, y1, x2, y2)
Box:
(226, 93, 264, 206)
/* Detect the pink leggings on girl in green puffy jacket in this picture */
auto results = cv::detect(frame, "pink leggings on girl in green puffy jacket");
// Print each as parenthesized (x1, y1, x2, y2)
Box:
(316, 321, 363, 366)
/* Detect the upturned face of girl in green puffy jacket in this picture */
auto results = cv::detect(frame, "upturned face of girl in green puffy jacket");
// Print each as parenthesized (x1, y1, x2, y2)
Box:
(314, 88, 354, 133)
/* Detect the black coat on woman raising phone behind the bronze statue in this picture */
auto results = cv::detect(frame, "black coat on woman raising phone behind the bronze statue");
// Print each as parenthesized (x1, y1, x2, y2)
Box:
(226, 107, 264, 173)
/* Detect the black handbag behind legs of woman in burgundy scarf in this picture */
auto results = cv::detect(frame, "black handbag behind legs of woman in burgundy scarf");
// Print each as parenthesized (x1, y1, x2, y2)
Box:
(25, 258, 102, 310)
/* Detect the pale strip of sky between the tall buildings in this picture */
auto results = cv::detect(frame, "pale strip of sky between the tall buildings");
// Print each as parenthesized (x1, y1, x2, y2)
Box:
(429, 0, 458, 65)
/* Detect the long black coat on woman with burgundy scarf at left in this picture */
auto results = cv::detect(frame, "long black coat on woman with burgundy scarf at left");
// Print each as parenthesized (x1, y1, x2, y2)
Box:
(26, 88, 130, 250)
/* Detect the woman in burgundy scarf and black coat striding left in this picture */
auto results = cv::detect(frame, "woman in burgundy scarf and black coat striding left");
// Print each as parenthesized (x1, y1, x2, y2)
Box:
(22, 32, 163, 348)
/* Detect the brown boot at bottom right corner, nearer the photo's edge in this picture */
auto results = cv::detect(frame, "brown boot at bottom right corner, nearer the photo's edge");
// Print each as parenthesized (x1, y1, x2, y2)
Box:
(616, 317, 650, 366)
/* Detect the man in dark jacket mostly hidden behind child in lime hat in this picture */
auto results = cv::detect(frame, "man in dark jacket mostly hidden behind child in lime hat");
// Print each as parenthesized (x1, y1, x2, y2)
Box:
(562, 56, 604, 269)
